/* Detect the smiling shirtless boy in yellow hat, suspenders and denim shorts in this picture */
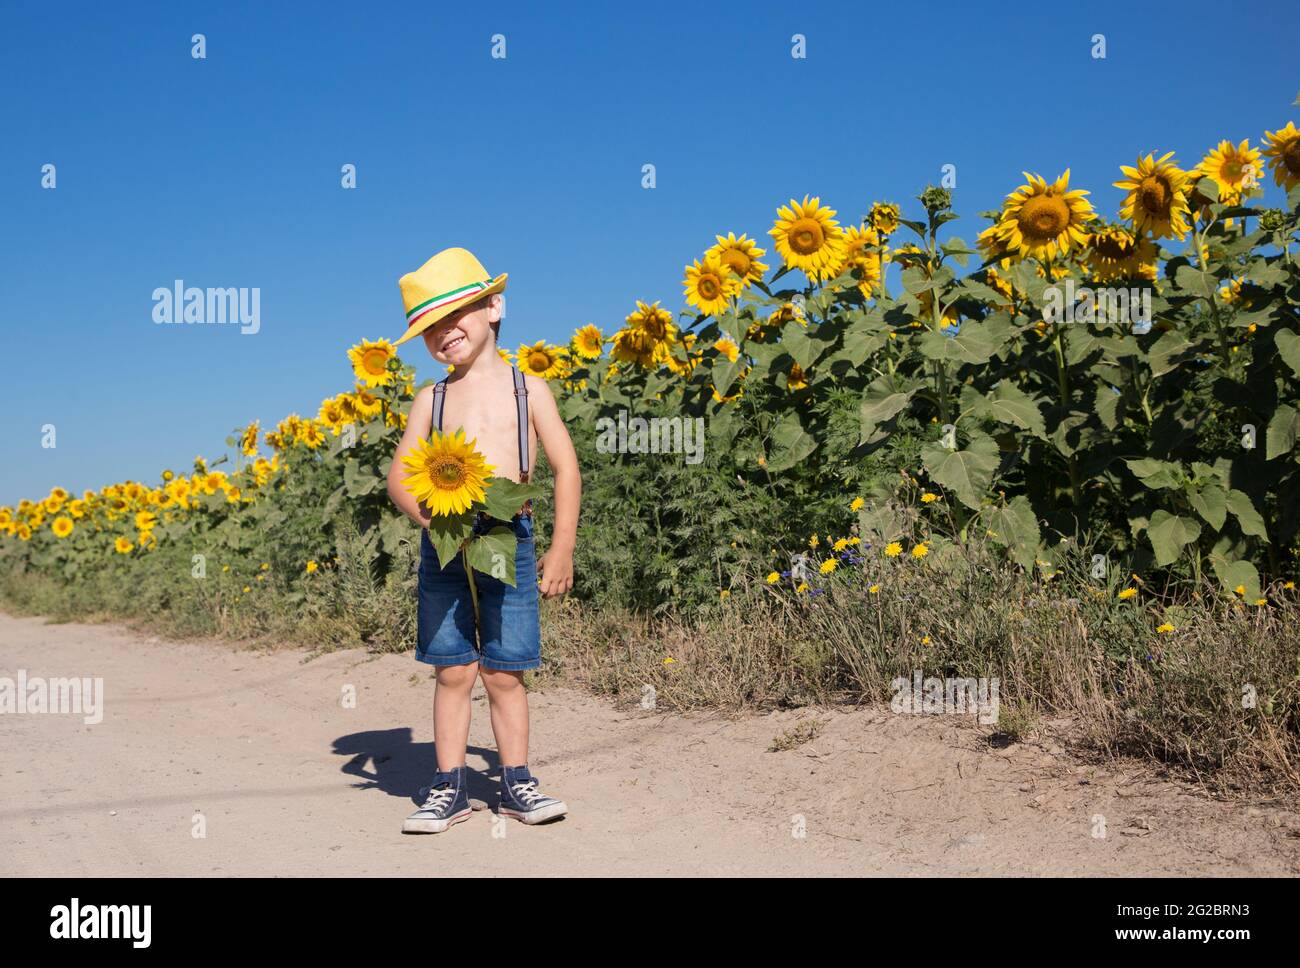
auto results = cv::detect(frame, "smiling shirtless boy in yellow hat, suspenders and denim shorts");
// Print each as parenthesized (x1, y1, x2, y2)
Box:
(389, 248, 582, 833)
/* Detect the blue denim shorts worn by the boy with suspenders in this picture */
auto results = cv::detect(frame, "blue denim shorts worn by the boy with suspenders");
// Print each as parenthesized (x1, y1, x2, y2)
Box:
(415, 515, 542, 672)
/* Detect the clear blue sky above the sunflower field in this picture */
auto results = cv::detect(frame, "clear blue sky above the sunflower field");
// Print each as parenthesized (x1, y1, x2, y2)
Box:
(0, 0, 1300, 504)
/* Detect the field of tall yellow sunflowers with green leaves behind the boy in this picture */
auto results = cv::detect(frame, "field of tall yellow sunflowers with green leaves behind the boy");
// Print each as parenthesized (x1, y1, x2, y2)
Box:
(0, 123, 1300, 612)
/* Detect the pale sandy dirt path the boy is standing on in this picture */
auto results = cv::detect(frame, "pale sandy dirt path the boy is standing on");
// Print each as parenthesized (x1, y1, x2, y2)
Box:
(0, 615, 1300, 876)
